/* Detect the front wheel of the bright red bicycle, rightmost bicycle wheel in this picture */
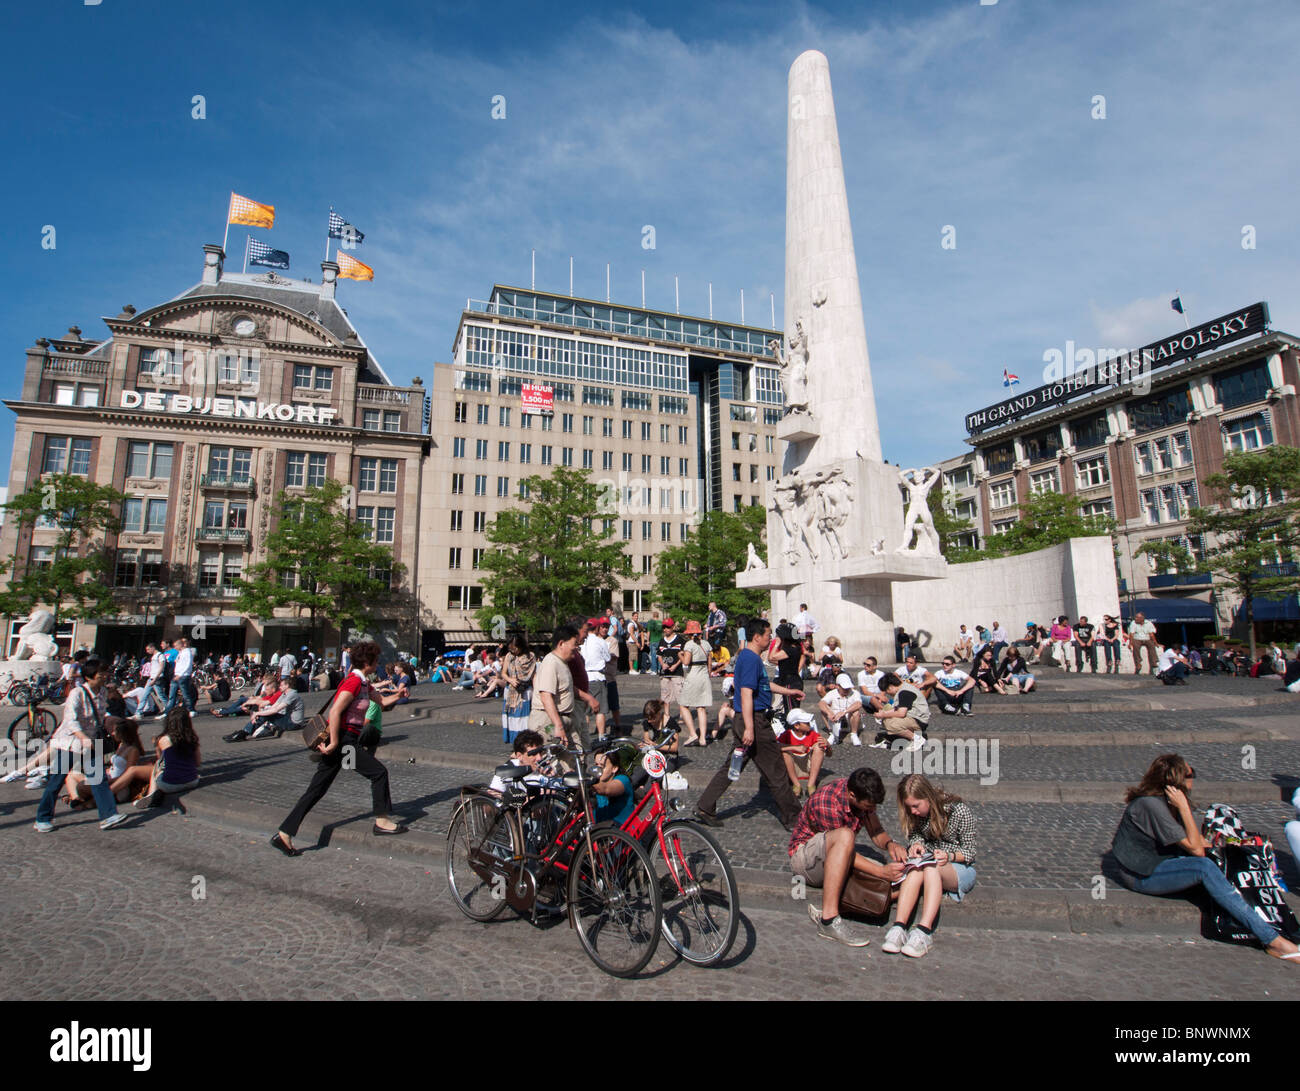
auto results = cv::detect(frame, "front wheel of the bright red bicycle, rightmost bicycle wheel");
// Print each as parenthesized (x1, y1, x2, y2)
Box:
(649, 819, 740, 966)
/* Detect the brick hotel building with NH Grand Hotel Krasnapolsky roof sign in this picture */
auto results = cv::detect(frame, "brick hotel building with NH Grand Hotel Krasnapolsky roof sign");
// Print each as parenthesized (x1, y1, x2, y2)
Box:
(961, 303, 1300, 637)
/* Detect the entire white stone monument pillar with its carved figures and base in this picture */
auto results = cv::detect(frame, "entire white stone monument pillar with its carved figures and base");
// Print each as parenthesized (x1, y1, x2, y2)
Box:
(736, 51, 946, 662)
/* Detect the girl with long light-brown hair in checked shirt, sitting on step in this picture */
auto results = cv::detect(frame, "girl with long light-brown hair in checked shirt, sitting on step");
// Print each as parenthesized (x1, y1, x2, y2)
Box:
(880, 772, 975, 958)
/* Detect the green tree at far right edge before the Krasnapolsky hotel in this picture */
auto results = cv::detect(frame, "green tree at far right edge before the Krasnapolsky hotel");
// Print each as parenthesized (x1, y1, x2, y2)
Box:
(1187, 446, 1300, 658)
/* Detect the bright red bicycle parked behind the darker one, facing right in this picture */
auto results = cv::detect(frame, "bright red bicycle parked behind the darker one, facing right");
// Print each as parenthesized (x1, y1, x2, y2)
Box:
(601, 732, 740, 966)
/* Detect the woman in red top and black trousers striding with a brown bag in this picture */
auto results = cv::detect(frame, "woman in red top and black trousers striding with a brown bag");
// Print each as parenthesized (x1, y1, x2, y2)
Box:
(270, 640, 407, 856)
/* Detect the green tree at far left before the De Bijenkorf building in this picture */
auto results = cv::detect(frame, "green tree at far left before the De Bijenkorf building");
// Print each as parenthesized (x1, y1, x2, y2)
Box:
(0, 473, 126, 625)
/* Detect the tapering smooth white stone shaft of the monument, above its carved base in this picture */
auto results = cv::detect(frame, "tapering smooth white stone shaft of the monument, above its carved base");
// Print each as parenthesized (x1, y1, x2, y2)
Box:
(785, 49, 883, 468)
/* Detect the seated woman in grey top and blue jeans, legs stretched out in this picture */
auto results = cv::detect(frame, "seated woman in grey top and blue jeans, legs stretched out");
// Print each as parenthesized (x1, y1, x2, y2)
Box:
(1110, 754, 1300, 962)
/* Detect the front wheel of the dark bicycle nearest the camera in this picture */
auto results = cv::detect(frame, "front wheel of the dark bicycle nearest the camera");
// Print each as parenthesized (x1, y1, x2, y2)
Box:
(568, 826, 663, 978)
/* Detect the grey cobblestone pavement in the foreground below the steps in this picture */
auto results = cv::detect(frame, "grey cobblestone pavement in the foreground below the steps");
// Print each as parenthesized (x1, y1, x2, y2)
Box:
(0, 814, 1297, 1001)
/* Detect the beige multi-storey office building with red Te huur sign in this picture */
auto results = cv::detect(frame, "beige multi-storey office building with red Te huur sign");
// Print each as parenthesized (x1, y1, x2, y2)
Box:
(419, 285, 781, 647)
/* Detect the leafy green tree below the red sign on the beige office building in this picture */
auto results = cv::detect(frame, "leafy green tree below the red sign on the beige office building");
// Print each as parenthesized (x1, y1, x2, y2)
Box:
(475, 467, 629, 635)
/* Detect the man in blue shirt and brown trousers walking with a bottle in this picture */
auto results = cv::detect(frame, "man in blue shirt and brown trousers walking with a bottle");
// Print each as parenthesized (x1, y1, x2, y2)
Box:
(696, 618, 800, 830)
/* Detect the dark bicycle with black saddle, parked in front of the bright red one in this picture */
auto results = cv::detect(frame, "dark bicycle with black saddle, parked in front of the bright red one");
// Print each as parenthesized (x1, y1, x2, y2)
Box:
(447, 745, 663, 978)
